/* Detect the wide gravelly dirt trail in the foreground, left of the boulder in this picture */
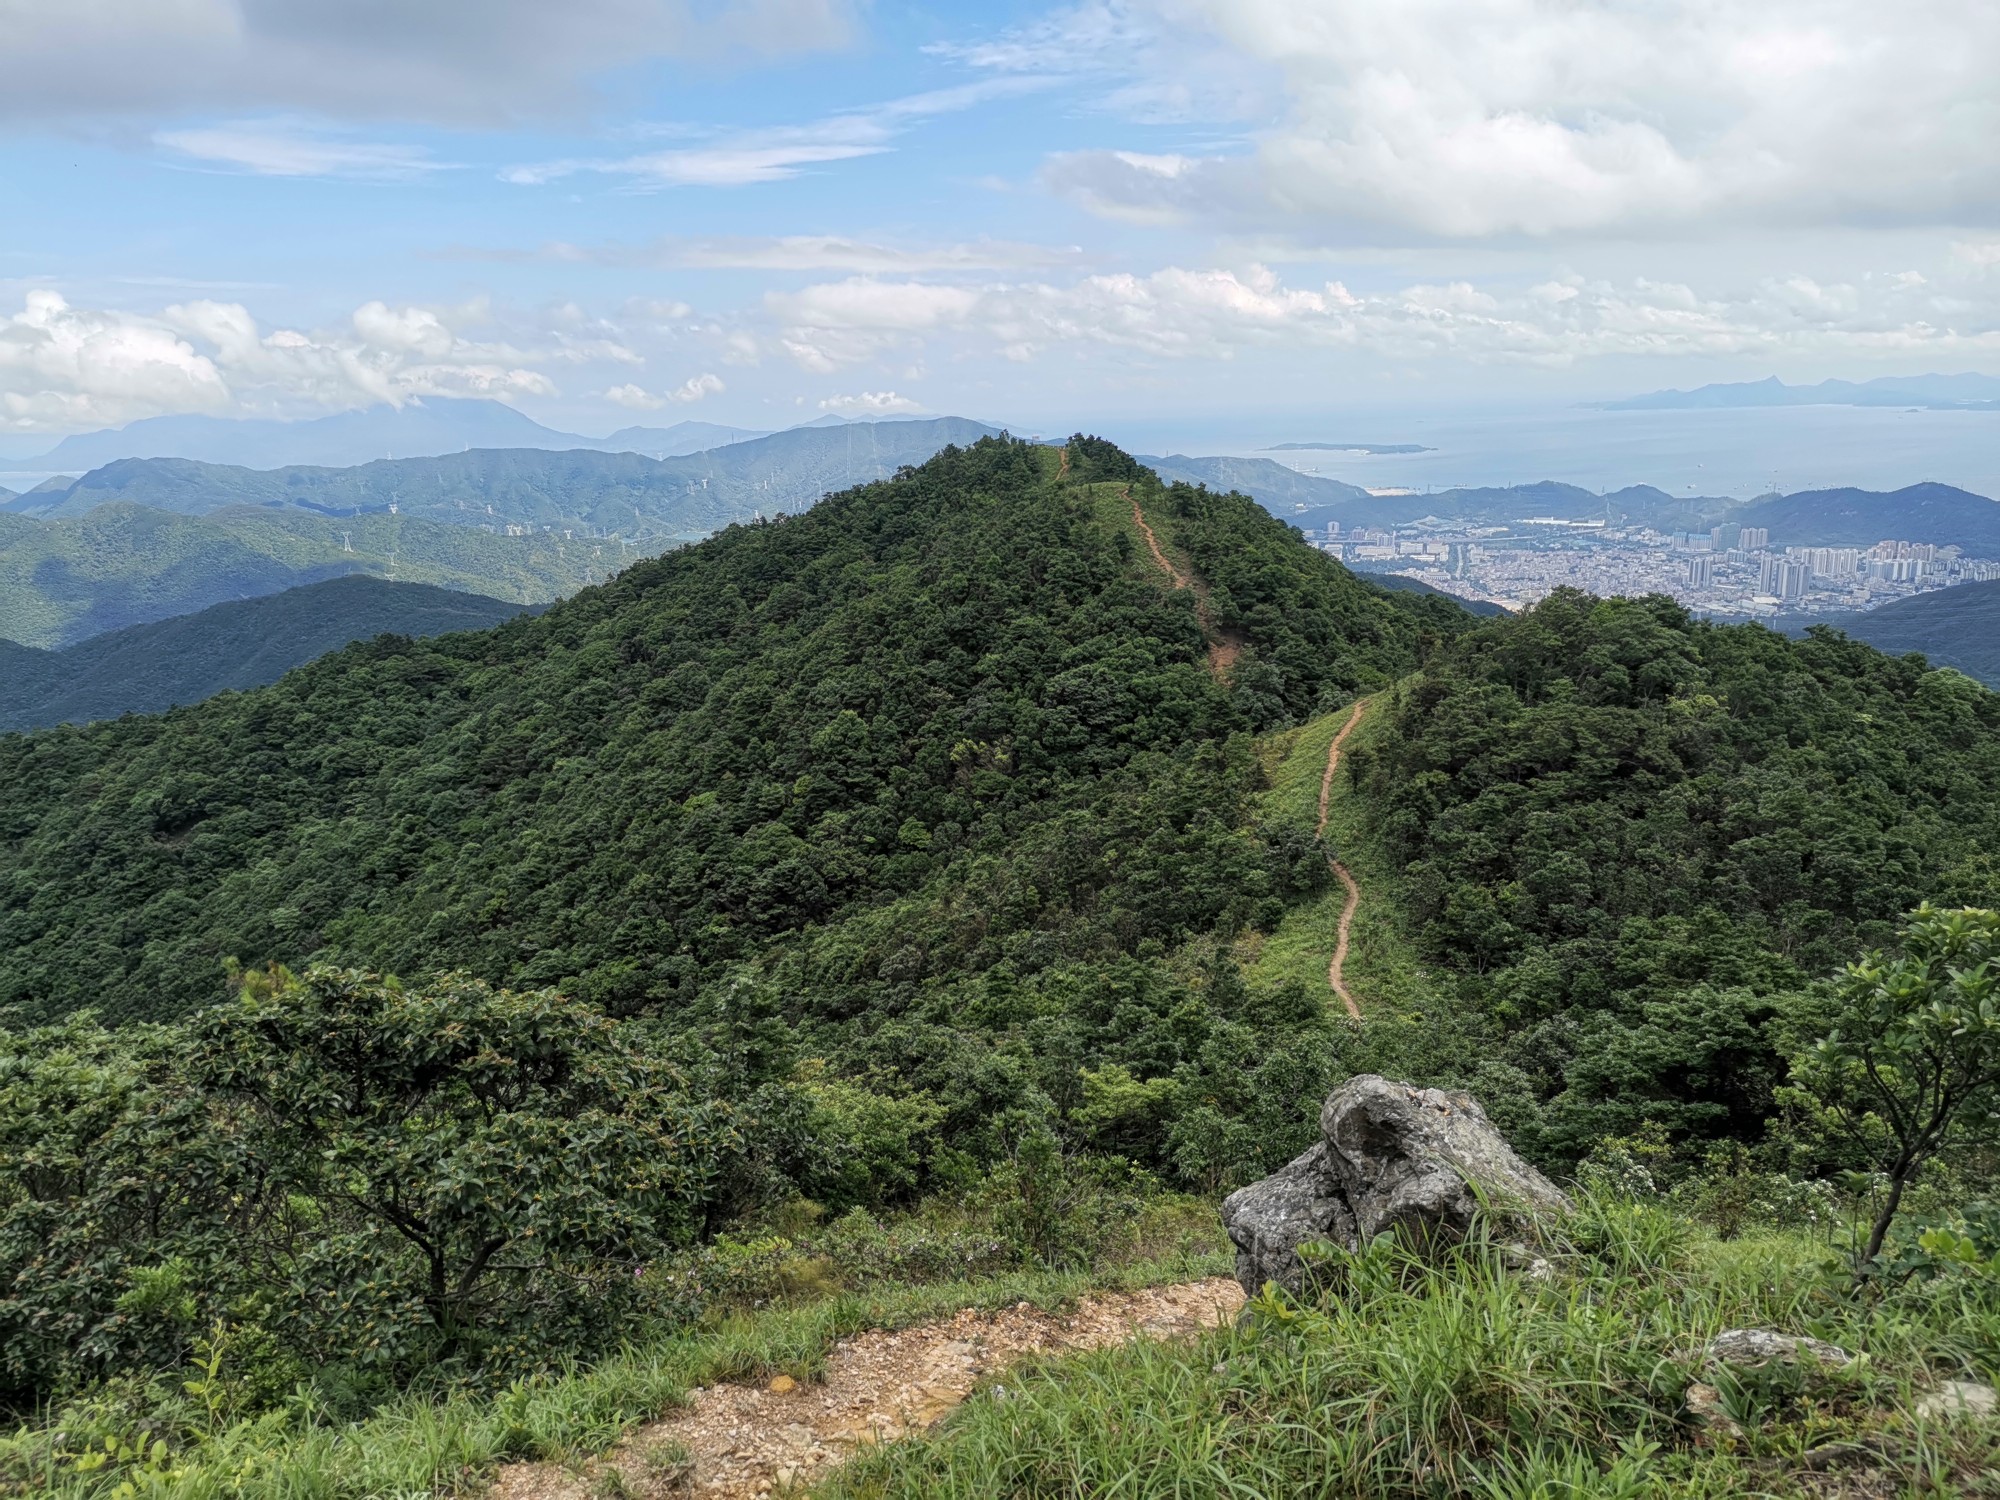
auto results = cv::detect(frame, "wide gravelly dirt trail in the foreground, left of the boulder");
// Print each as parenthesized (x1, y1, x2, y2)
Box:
(490, 1276, 1244, 1500)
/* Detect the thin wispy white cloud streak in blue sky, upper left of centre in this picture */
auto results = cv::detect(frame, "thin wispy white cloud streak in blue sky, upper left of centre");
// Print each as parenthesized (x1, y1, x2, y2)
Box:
(500, 78, 1042, 188)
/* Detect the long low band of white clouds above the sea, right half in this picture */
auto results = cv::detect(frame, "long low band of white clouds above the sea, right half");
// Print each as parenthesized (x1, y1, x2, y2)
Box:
(766, 266, 2000, 372)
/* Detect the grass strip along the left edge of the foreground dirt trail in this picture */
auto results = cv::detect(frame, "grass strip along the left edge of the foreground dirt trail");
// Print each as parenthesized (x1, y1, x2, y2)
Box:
(0, 1250, 1230, 1500)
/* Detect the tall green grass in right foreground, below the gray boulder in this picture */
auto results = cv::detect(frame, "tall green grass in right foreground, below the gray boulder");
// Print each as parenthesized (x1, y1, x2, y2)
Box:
(818, 1204, 2000, 1500)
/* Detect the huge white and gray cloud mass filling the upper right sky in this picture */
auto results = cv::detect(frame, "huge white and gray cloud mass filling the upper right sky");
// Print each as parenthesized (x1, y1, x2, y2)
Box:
(1000, 0, 2000, 238)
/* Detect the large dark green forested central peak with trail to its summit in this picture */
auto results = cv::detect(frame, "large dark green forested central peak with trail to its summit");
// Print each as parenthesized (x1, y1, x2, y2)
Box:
(0, 440, 1468, 1016)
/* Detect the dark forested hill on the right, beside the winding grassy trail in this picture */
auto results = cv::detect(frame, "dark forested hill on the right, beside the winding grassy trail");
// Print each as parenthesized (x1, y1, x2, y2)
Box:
(1352, 590, 2000, 1160)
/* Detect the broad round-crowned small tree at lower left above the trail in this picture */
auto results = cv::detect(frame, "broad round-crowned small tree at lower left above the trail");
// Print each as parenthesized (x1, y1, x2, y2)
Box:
(194, 968, 734, 1354)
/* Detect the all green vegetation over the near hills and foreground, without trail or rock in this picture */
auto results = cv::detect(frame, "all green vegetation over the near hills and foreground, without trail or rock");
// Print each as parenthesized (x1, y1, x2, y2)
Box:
(0, 438, 2000, 1500)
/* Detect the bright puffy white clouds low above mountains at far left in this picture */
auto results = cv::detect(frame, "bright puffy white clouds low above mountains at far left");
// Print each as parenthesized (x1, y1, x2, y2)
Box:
(0, 288, 564, 432)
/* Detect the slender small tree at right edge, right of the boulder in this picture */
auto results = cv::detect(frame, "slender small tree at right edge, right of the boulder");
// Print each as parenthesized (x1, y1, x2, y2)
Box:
(1794, 906, 2000, 1264)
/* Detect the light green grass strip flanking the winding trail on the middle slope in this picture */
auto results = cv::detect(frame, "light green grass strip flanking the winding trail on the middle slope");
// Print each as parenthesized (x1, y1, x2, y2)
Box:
(1244, 694, 1434, 1028)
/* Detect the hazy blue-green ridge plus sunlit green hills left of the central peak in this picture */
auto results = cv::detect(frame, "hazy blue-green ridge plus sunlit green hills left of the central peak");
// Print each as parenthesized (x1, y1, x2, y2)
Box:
(0, 418, 990, 648)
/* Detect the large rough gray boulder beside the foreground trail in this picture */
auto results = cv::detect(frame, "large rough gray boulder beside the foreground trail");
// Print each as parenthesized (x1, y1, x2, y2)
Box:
(1222, 1074, 1568, 1296)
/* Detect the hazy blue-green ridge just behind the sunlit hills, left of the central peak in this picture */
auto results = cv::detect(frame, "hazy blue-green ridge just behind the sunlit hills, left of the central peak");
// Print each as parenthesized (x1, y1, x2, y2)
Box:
(14, 418, 990, 544)
